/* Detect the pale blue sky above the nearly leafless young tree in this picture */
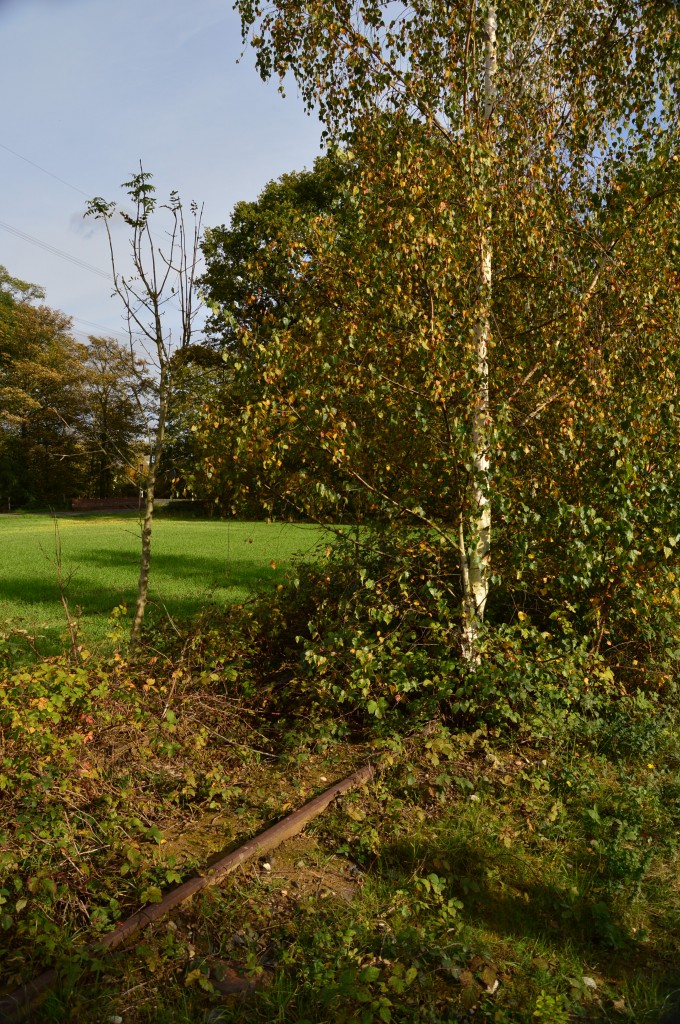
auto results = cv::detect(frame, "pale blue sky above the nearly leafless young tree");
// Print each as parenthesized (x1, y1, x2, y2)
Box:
(0, 0, 321, 340)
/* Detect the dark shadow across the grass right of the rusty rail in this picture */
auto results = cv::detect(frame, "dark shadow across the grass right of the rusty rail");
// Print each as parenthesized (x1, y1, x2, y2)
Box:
(374, 831, 680, 1024)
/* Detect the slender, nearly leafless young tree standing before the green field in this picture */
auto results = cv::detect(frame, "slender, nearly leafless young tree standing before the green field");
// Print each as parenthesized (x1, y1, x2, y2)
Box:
(86, 167, 202, 643)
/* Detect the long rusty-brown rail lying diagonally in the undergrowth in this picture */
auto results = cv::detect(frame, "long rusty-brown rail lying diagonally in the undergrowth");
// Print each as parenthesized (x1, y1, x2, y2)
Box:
(0, 765, 374, 1024)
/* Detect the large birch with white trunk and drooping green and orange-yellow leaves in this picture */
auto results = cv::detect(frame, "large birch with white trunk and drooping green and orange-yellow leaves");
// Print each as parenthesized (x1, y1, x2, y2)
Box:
(209, 0, 680, 671)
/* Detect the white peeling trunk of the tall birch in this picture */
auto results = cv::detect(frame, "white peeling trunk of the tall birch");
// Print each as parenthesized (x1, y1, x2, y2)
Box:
(459, 4, 497, 660)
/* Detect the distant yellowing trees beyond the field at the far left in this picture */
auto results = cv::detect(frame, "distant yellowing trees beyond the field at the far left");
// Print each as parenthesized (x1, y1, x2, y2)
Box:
(0, 267, 153, 506)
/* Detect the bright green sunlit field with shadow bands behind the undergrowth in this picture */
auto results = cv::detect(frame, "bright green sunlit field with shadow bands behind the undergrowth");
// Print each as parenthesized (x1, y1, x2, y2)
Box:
(0, 513, 322, 651)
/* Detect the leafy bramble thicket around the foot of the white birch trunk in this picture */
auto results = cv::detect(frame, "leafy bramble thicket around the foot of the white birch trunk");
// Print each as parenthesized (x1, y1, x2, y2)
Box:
(240, 528, 675, 758)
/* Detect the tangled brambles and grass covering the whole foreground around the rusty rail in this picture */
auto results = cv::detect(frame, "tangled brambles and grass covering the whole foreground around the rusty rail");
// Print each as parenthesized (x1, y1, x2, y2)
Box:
(0, 542, 680, 1024)
